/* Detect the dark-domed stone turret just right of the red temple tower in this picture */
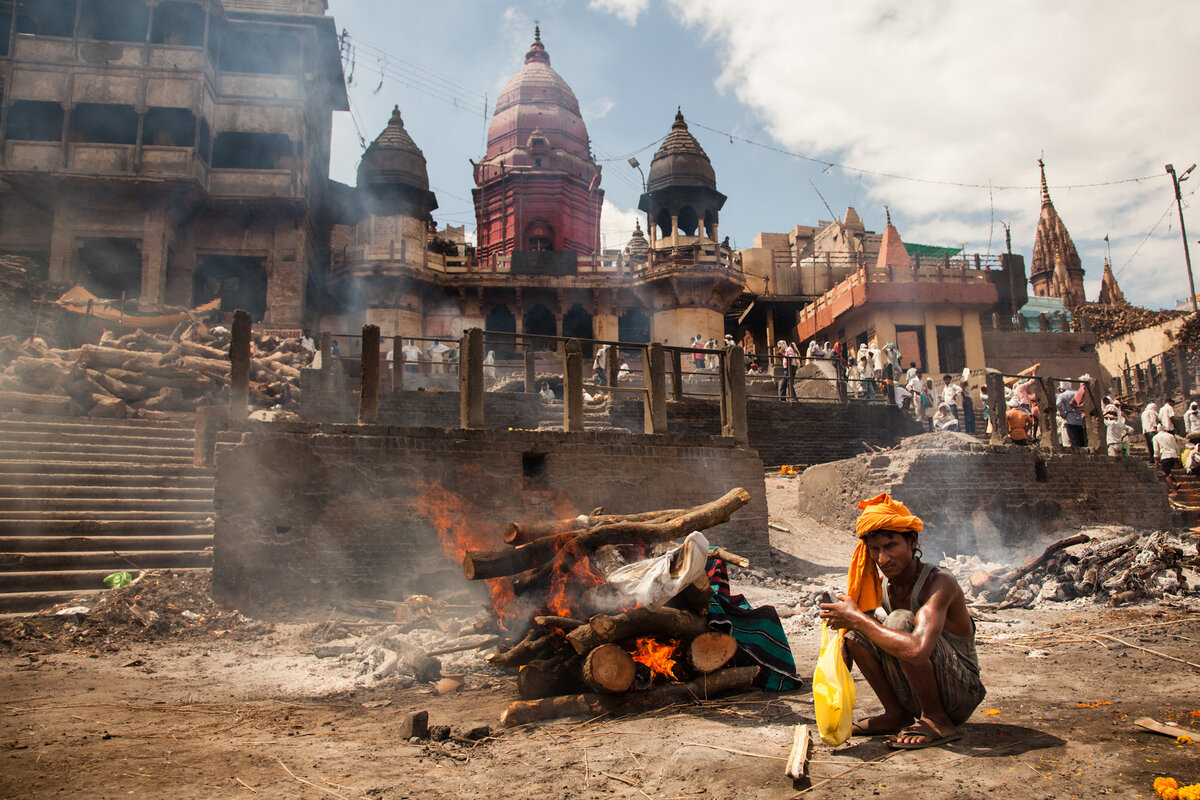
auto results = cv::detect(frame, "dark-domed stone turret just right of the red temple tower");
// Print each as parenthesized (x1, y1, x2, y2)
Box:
(637, 109, 745, 345)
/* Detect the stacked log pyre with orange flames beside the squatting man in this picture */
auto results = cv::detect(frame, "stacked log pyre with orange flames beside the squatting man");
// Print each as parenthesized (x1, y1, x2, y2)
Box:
(463, 488, 758, 726)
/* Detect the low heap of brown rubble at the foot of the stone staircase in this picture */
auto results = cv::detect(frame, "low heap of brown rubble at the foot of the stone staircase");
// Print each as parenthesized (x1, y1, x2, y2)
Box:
(0, 570, 272, 652)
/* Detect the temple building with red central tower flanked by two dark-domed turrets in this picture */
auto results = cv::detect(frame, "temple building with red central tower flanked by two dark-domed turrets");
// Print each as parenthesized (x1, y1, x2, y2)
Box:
(322, 30, 744, 355)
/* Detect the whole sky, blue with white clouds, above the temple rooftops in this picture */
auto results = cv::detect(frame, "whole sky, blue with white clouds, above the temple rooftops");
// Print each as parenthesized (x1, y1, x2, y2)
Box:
(330, 0, 1200, 308)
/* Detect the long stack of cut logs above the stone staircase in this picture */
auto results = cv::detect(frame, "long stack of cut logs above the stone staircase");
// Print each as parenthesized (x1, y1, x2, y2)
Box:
(0, 325, 308, 419)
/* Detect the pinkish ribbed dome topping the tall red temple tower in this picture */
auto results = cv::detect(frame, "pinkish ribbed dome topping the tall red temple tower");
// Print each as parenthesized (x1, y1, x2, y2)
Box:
(485, 29, 592, 162)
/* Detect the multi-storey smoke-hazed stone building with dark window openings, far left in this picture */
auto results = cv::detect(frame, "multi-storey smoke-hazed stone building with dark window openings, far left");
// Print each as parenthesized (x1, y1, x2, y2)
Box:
(0, 0, 348, 329)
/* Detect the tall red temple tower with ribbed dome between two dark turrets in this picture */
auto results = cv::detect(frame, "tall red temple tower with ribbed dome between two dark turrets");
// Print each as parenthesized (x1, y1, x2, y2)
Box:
(472, 29, 604, 275)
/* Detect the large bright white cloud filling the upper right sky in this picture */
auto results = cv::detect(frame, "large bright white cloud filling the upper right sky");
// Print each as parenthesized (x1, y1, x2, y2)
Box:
(671, 0, 1200, 306)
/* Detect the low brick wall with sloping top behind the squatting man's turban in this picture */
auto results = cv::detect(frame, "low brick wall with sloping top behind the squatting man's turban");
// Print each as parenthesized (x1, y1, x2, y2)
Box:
(798, 434, 1174, 558)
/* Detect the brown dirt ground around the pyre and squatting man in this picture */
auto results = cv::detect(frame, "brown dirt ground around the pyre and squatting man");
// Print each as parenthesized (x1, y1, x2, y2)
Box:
(0, 477, 1200, 800)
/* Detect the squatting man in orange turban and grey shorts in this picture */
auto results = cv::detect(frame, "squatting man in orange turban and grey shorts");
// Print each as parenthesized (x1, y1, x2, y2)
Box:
(821, 494, 986, 750)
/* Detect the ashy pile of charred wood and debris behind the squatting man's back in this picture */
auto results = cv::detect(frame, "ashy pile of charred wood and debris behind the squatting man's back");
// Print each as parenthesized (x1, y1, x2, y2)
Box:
(970, 531, 1200, 608)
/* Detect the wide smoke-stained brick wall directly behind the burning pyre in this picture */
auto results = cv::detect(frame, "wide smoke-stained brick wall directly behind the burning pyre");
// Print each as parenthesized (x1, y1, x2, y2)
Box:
(212, 425, 768, 608)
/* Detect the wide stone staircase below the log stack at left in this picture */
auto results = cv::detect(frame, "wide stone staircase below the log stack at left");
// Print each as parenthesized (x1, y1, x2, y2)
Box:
(0, 414, 212, 614)
